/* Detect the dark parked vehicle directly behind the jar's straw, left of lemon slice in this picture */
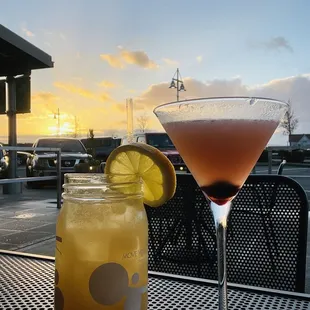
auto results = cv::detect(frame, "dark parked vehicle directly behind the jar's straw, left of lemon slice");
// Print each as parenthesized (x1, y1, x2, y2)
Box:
(81, 137, 121, 162)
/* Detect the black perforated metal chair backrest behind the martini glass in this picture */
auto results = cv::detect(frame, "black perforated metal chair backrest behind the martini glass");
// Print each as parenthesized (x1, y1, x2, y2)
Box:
(146, 174, 308, 292)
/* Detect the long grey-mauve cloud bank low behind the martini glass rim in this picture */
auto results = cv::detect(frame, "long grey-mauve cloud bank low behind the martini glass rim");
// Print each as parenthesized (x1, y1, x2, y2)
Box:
(134, 74, 310, 138)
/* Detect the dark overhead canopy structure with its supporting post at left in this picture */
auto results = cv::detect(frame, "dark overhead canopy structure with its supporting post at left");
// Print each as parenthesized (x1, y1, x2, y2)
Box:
(0, 24, 54, 194)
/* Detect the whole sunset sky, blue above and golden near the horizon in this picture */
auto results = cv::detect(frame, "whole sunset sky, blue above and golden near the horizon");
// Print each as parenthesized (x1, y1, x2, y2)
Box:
(0, 0, 310, 144)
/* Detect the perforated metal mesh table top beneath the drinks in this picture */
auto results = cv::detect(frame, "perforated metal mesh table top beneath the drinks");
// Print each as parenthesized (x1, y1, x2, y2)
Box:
(0, 253, 310, 310)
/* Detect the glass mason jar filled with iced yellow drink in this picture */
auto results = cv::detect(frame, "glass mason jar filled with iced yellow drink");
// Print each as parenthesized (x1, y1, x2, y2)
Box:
(55, 173, 148, 310)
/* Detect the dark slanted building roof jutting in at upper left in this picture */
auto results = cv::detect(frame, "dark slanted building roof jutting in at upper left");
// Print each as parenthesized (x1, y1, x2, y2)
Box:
(0, 24, 54, 76)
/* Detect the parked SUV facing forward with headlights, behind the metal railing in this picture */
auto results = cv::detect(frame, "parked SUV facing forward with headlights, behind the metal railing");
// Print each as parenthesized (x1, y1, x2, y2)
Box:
(26, 137, 92, 188)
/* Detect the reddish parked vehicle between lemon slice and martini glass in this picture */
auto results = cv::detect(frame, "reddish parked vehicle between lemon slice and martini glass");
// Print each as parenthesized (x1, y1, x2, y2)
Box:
(121, 132, 188, 172)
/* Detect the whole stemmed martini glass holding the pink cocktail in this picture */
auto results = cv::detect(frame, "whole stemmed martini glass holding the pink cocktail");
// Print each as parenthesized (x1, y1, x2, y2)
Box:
(154, 97, 287, 310)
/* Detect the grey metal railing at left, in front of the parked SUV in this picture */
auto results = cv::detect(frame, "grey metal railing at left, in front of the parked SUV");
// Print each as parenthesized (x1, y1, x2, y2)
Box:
(0, 146, 61, 209)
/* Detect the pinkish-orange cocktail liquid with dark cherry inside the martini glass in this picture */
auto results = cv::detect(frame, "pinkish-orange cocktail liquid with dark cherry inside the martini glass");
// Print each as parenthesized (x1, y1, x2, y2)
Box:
(163, 119, 278, 205)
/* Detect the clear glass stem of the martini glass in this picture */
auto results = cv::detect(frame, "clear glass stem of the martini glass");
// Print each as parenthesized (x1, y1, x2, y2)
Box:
(211, 202, 231, 310)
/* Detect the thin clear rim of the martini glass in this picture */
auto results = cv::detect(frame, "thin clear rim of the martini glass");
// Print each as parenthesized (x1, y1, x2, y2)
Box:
(153, 96, 288, 114)
